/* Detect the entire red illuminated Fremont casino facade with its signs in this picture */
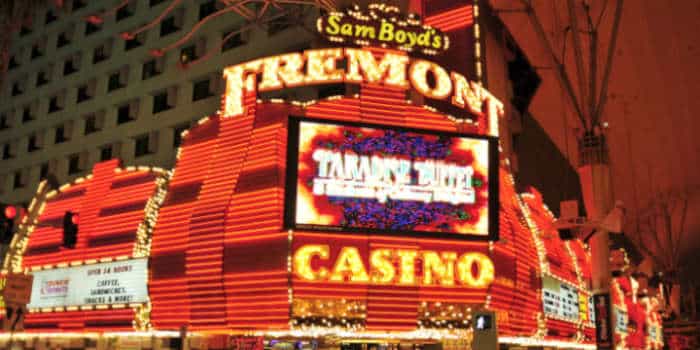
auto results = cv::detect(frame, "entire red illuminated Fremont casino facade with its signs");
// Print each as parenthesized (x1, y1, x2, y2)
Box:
(4, 0, 660, 349)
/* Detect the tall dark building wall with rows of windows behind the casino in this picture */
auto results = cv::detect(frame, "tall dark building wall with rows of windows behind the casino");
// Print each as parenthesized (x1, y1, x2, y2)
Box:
(0, 0, 318, 203)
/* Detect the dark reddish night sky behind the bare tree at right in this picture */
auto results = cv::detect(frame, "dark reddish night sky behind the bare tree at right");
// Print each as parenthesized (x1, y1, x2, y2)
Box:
(490, 0, 700, 272)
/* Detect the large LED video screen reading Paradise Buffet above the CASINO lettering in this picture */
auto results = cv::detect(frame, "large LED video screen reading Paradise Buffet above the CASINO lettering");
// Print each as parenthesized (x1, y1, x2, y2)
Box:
(285, 117, 498, 240)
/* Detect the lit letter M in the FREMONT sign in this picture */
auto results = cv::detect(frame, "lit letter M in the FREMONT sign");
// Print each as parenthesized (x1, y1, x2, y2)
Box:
(345, 49, 408, 89)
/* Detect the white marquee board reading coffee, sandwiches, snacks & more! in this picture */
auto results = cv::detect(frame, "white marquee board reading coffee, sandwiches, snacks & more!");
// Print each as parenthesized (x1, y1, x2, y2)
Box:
(27, 259, 148, 308)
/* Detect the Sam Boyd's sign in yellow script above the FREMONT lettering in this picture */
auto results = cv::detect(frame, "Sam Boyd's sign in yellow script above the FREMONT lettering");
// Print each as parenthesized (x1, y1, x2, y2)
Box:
(316, 4, 450, 55)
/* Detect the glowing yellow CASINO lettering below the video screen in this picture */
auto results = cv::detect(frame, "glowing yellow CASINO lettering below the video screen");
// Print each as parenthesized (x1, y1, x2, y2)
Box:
(292, 244, 495, 289)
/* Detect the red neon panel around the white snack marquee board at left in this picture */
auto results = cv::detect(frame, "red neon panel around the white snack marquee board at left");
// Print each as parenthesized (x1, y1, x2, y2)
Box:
(23, 160, 164, 332)
